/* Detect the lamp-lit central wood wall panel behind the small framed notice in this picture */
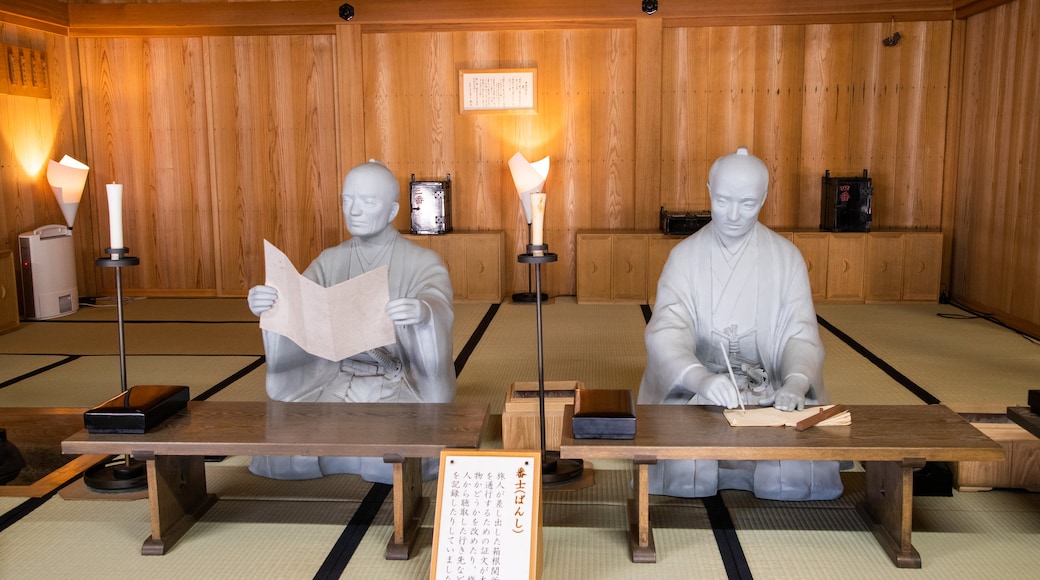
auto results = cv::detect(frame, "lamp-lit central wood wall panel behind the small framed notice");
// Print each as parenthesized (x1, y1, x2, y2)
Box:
(363, 27, 634, 294)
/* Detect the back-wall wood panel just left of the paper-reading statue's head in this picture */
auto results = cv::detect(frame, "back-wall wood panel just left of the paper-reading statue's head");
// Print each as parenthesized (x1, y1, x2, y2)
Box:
(206, 35, 345, 295)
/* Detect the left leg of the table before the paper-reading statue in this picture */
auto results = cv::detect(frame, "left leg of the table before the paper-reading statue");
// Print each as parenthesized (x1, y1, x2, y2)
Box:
(136, 455, 216, 556)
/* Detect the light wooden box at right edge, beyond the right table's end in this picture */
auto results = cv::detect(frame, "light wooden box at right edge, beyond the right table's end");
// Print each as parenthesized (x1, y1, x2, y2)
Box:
(950, 412, 1040, 492)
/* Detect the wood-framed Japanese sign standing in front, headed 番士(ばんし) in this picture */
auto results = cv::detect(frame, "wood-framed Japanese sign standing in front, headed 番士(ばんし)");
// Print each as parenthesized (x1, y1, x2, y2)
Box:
(430, 449, 542, 580)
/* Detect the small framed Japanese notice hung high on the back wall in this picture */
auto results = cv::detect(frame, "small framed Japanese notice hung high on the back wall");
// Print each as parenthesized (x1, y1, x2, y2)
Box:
(459, 69, 536, 113)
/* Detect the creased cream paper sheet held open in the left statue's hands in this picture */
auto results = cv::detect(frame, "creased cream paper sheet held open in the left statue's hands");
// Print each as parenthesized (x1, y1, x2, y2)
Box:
(260, 240, 396, 361)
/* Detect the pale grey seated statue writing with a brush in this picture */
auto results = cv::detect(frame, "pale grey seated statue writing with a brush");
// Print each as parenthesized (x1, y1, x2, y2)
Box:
(639, 148, 842, 500)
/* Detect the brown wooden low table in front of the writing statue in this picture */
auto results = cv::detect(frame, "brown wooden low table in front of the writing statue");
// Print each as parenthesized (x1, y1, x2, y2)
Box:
(560, 405, 1004, 568)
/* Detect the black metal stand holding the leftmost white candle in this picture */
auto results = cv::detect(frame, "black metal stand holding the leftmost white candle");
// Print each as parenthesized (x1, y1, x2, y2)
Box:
(83, 247, 148, 492)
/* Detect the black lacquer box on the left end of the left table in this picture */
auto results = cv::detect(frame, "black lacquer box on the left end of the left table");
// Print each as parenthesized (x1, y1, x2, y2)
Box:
(83, 385, 188, 433)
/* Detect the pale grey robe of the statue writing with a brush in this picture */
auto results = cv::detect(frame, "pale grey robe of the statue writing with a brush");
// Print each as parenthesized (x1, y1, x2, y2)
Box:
(639, 223, 842, 500)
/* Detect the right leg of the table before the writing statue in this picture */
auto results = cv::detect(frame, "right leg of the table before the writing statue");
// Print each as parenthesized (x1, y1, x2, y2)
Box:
(856, 458, 925, 568)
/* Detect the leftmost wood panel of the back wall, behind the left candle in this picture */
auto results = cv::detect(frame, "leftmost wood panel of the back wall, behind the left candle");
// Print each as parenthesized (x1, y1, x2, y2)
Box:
(79, 38, 214, 294)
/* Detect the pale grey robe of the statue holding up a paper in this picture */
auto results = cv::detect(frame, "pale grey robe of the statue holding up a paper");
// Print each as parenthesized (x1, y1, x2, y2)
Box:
(250, 234, 456, 483)
